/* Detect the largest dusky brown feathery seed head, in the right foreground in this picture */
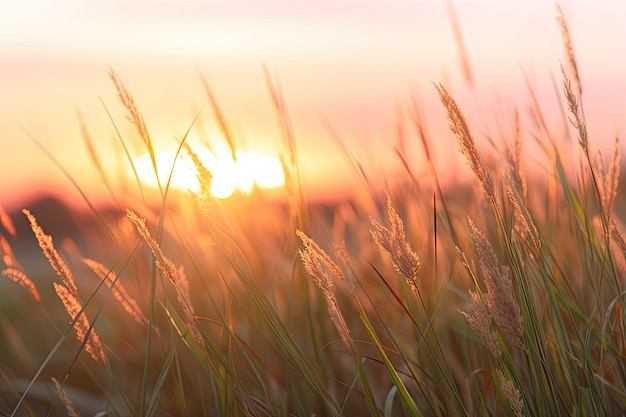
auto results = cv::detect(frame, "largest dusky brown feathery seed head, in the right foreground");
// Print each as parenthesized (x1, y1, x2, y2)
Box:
(468, 218, 524, 346)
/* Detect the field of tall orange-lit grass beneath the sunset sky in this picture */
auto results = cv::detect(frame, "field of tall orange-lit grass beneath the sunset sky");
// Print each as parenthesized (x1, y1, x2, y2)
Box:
(0, 11, 626, 417)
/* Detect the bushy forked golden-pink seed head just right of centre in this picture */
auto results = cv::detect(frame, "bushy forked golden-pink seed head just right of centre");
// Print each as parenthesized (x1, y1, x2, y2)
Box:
(370, 195, 422, 288)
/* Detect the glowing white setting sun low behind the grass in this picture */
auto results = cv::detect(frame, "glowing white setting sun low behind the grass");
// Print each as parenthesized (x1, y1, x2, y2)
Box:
(131, 150, 285, 199)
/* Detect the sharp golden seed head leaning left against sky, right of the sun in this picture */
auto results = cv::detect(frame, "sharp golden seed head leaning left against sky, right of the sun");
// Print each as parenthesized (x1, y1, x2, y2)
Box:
(435, 83, 495, 202)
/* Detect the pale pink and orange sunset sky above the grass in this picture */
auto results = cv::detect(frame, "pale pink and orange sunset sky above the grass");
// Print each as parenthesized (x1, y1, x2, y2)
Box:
(0, 0, 626, 207)
